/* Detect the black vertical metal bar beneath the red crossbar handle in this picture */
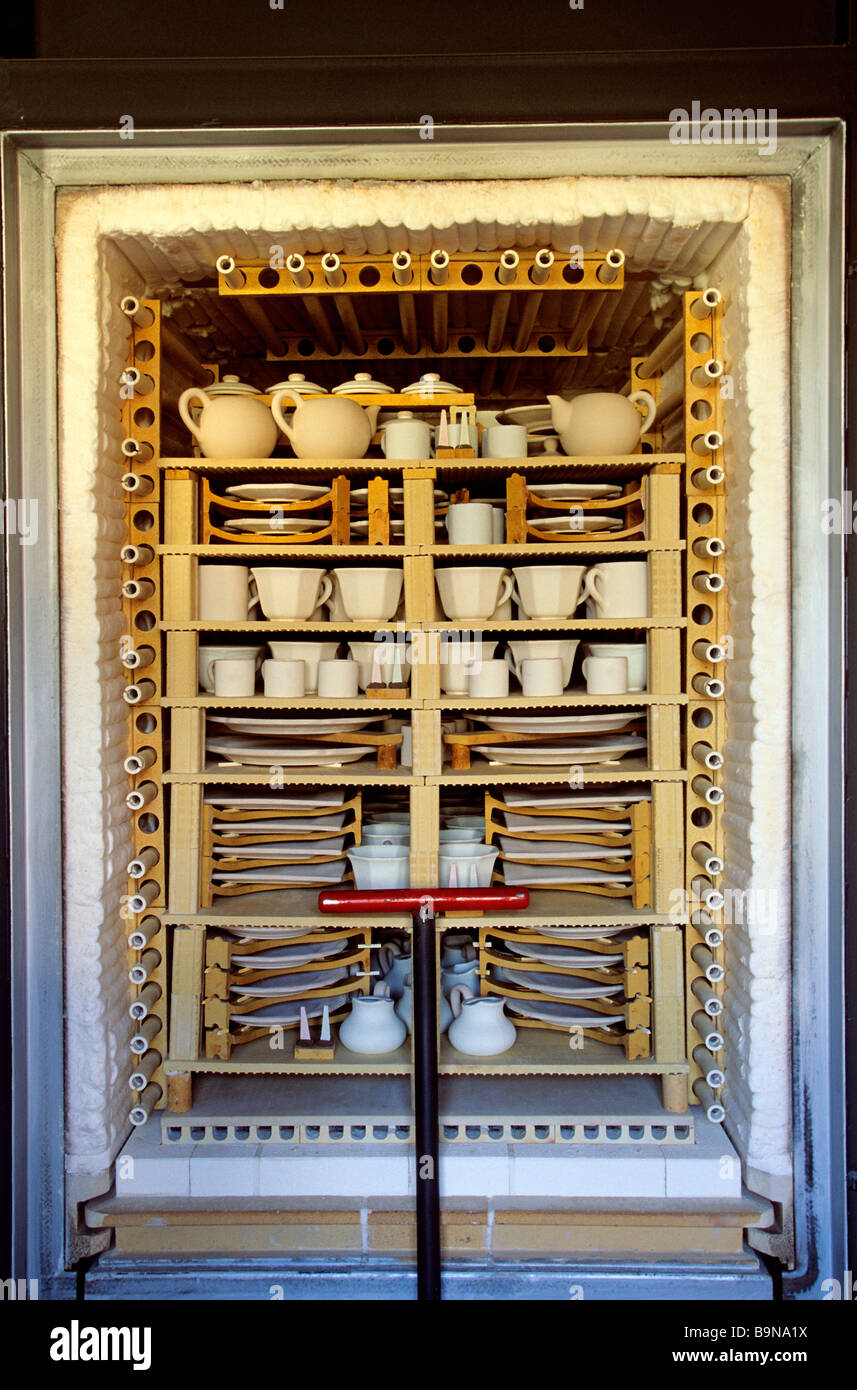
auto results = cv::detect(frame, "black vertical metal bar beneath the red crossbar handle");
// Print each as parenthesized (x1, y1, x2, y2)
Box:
(413, 902, 440, 1302)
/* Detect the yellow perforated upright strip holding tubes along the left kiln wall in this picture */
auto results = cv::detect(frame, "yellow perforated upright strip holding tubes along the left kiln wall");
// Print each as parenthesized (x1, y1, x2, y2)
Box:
(121, 299, 168, 1109)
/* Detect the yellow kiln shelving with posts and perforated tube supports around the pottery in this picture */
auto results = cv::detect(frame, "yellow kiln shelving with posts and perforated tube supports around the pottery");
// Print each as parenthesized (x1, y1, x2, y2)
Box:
(116, 265, 725, 1111)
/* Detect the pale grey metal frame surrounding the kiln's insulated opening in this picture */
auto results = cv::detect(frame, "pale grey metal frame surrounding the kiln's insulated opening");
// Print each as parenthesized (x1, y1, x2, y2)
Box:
(3, 120, 846, 1298)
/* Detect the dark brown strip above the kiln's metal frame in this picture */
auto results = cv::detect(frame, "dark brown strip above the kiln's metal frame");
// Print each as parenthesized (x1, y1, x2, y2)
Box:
(0, 0, 857, 1277)
